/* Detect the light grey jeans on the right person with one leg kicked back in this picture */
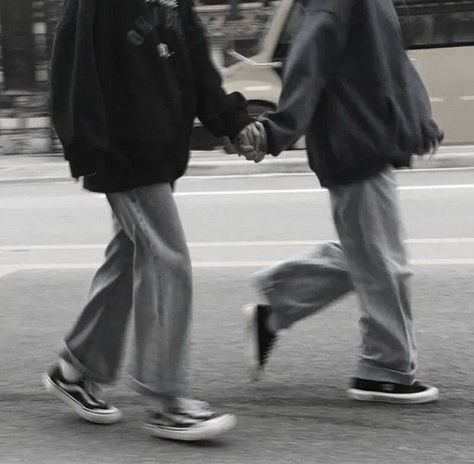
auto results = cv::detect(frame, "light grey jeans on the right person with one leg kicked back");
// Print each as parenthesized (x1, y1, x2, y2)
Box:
(255, 169, 416, 384)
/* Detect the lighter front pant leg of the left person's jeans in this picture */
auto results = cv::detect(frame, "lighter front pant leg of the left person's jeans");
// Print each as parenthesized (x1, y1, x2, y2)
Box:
(108, 184, 192, 398)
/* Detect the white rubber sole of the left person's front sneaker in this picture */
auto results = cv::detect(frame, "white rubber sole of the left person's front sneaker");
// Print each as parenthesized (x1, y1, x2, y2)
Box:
(144, 414, 237, 441)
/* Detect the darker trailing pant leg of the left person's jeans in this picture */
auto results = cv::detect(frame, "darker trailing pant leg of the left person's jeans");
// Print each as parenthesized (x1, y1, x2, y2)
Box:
(60, 213, 133, 383)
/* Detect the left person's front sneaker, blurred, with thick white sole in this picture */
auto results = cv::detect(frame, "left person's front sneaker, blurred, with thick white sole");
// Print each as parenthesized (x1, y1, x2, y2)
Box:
(145, 400, 237, 441)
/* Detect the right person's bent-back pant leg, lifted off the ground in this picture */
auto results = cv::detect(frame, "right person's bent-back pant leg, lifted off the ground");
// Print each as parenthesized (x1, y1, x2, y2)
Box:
(254, 242, 353, 329)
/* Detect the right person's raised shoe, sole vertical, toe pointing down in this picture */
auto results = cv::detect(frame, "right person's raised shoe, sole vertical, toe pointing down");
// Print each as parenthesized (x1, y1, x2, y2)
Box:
(242, 305, 278, 381)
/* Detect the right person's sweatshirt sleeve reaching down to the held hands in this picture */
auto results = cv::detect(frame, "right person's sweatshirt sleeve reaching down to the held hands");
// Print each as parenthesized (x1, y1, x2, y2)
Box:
(262, 0, 354, 156)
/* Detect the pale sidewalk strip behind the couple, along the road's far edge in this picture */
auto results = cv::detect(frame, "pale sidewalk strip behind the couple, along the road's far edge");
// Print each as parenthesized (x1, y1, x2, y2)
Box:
(0, 145, 474, 183)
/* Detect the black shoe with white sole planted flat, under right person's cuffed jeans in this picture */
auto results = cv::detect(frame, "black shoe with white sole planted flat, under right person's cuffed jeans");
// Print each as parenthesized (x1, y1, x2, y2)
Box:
(347, 378, 439, 404)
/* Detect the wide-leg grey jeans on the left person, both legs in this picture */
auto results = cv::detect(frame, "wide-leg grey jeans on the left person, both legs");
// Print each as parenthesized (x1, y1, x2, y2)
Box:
(60, 184, 192, 398)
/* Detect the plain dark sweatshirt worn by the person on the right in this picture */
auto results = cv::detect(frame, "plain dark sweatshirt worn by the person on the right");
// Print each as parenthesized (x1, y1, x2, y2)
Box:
(263, 0, 442, 187)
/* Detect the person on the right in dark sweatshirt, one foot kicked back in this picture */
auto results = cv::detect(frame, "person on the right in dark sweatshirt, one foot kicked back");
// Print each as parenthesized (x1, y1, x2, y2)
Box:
(239, 0, 443, 404)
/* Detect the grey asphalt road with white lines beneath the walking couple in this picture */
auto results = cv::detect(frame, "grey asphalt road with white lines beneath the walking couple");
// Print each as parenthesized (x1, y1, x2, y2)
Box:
(0, 169, 474, 464)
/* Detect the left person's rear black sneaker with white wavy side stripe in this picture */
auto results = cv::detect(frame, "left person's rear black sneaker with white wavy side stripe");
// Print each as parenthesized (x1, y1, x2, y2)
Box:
(42, 366, 122, 424)
